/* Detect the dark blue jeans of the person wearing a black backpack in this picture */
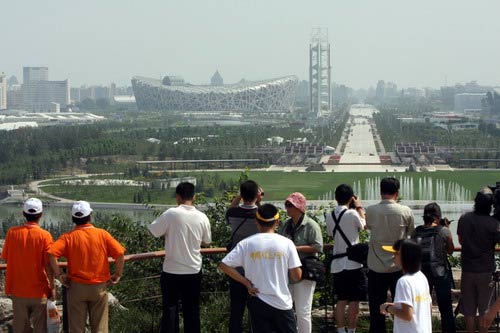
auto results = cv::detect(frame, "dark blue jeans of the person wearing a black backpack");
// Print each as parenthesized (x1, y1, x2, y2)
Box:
(426, 271, 456, 333)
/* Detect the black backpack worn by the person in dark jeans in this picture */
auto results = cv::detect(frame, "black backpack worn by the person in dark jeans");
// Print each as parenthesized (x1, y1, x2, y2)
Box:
(413, 225, 448, 277)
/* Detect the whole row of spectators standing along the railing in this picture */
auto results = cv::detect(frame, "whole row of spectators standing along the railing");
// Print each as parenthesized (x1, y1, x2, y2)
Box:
(1, 177, 500, 333)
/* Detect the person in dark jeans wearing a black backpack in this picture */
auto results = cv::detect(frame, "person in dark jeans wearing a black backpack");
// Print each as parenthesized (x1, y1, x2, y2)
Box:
(412, 202, 456, 333)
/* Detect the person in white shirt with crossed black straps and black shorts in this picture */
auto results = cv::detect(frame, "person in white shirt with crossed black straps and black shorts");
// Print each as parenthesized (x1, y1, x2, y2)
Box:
(326, 184, 367, 333)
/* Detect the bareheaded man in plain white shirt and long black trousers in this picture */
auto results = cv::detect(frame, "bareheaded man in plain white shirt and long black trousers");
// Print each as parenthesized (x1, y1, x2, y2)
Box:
(148, 182, 211, 333)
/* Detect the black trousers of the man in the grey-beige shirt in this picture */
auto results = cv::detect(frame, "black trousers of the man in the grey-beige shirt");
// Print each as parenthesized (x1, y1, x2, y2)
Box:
(368, 270, 402, 333)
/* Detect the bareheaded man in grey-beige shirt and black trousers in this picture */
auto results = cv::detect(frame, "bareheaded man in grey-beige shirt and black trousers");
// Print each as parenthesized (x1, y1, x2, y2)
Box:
(366, 177, 415, 333)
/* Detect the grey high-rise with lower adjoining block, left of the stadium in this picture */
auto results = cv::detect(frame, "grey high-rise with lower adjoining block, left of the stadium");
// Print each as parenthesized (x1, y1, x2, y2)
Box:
(22, 67, 70, 112)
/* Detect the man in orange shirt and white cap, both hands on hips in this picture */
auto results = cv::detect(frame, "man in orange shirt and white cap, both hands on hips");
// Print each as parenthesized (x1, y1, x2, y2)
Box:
(49, 201, 125, 333)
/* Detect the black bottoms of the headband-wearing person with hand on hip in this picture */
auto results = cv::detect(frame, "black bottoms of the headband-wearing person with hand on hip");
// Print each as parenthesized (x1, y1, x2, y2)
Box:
(248, 297, 297, 333)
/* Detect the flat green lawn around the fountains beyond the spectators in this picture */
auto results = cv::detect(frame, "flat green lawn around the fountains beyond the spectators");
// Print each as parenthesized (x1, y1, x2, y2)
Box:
(43, 170, 500, 204)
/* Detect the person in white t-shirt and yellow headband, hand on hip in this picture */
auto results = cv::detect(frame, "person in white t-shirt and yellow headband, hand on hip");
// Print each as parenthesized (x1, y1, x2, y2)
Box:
(219, 204, 302, 333)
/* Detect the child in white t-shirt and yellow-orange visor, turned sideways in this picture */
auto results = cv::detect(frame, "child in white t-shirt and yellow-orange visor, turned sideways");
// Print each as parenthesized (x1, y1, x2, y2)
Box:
(380, 239, 432, 333)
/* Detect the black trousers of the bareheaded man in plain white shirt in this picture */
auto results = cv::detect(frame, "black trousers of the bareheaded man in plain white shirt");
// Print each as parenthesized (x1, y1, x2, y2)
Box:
(160, 271, 202, 333)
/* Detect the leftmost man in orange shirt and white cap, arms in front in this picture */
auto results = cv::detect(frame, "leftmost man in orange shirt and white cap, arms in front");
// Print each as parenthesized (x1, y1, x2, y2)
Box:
(2, 198, 54, 333)
